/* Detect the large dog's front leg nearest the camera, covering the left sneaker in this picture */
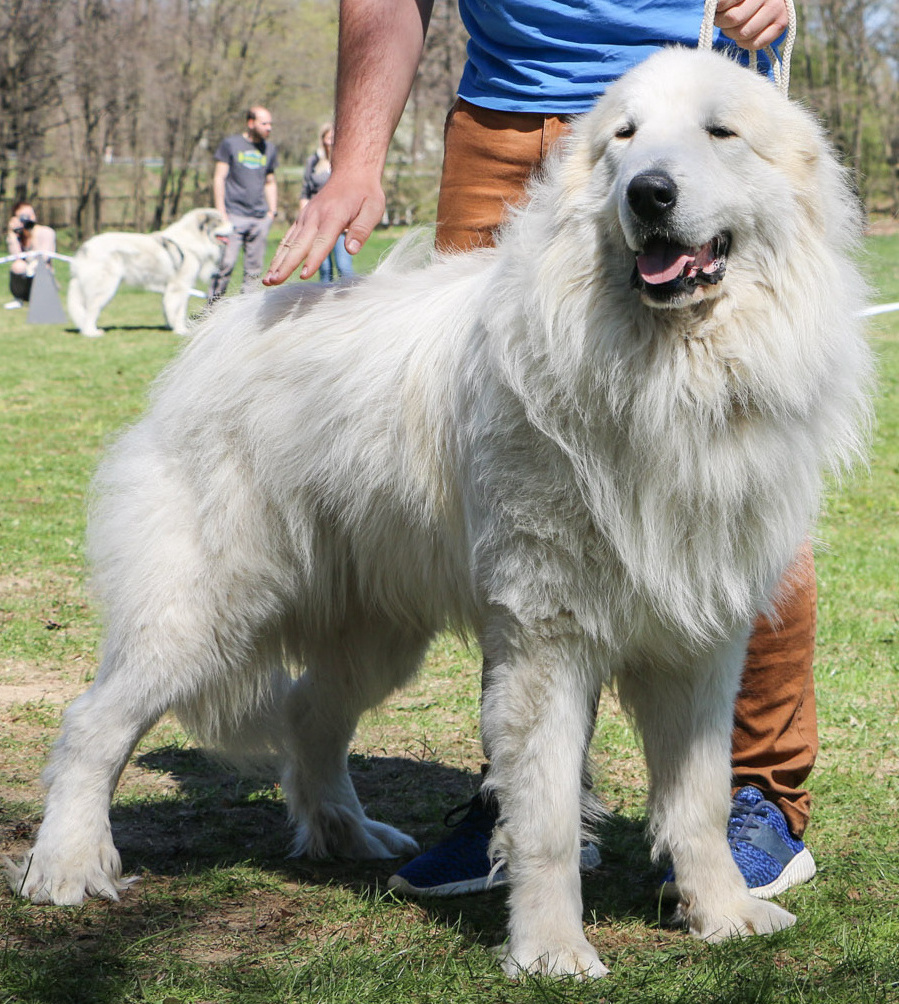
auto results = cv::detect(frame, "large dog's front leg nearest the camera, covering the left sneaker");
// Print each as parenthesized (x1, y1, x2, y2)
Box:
(482, 622, 608, 978)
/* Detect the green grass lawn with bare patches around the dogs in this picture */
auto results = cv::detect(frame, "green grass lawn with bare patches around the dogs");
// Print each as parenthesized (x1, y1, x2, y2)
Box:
(0, 233, 899, 1004)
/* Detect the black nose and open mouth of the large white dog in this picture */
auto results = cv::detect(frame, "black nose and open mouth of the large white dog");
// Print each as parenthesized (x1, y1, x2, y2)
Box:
(626, 171, 731, 303)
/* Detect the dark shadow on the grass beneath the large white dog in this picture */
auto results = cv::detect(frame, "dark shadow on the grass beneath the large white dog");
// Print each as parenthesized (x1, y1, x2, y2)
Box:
(111, 747, 659, 944)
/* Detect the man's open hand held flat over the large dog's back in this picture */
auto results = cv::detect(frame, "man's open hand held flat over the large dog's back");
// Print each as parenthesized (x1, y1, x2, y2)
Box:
(262, 169, 387, 286)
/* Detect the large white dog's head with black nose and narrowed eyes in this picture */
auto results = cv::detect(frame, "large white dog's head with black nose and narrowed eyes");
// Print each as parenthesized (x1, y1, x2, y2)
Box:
(561, 48, 857, 307)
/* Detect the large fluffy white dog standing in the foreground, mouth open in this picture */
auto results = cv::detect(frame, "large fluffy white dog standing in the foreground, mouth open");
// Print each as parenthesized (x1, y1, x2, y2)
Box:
(11, 50, 869, 976)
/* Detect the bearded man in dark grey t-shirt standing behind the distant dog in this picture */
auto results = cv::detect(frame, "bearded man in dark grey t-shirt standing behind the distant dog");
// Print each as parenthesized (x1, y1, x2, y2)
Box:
(209, 105, 278, 303)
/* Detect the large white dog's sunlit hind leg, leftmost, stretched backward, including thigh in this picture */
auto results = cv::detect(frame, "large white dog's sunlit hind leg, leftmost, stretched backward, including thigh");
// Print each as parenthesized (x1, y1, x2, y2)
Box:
(9, 491, 289, 905)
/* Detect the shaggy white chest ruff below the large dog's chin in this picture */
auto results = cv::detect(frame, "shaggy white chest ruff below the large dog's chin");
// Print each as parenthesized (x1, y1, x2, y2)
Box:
(484, 304, 815, 645)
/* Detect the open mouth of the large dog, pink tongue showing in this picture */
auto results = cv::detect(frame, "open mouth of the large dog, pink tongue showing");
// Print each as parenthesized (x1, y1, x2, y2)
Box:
(631, 233, 730, 302)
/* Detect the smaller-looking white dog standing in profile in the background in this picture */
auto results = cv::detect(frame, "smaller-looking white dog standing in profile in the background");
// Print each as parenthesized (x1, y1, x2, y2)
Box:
(68, 209, 231, 338)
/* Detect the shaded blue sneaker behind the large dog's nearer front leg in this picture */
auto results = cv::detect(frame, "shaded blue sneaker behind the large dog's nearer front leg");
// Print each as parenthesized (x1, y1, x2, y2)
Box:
(387, 792, 600, 896)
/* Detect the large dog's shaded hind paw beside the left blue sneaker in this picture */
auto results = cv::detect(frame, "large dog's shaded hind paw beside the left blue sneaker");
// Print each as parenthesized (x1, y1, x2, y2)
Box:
(290, 802, 419, 860)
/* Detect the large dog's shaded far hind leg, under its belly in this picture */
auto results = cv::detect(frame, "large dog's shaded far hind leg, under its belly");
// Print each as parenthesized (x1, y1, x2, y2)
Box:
(283, 617, 428, 858)
